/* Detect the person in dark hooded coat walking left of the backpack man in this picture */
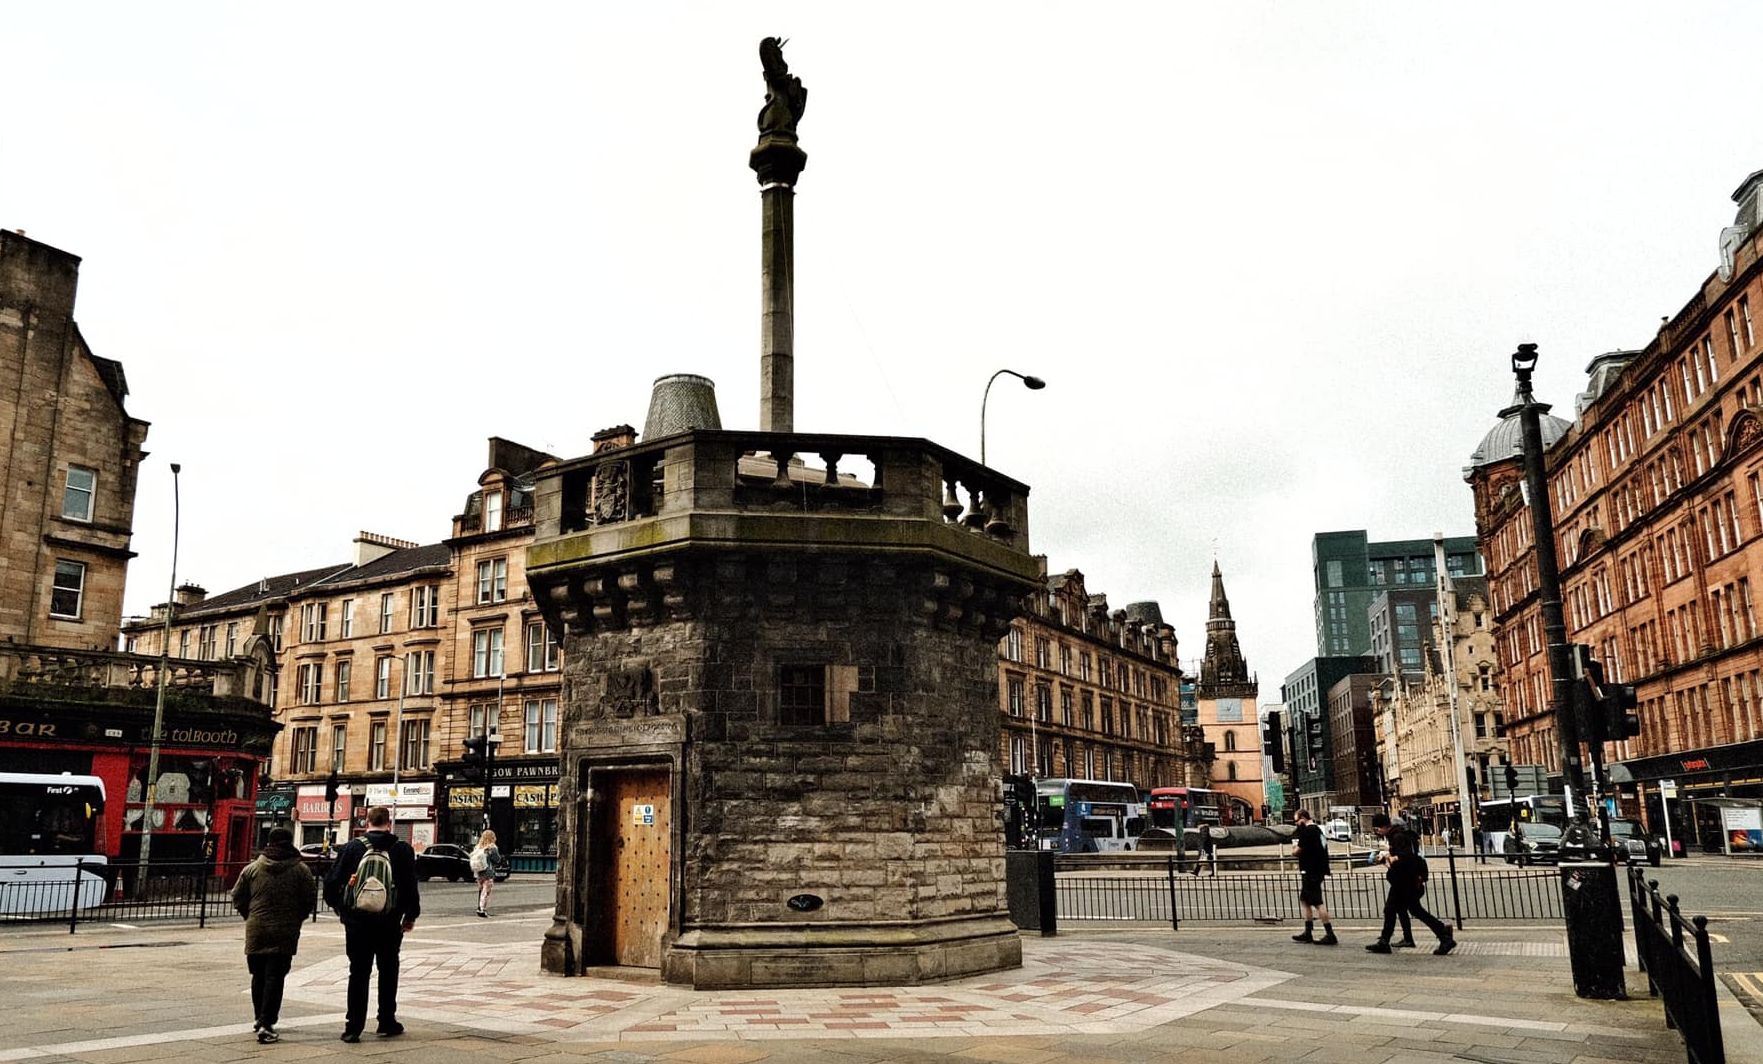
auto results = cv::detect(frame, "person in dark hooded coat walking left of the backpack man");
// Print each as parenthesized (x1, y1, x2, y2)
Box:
(233, 828, 319, 1045)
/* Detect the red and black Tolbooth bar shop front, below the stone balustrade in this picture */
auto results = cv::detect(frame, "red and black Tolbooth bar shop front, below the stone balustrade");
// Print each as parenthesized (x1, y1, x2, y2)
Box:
(0, 689, 279, 865)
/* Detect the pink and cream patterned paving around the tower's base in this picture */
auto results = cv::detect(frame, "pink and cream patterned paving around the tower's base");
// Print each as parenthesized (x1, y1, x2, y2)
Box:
(287, 939, 1292, 1041)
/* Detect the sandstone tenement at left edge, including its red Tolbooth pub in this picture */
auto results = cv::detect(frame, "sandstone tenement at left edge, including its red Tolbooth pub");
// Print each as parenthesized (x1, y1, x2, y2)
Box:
(0, 233, 275, 876)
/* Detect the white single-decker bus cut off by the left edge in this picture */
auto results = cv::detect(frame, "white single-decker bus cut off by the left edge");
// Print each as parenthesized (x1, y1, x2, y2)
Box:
(0, 772, 109, 916)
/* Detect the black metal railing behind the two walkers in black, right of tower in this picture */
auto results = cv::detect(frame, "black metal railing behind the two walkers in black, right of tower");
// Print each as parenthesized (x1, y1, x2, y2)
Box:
(1056, 849, 1562, 928)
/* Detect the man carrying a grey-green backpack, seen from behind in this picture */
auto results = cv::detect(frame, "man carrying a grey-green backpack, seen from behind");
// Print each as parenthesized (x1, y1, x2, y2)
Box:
(324, 805, 423, 1043)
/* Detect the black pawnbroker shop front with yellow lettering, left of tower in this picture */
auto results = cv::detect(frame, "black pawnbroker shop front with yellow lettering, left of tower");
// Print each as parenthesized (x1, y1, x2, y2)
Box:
(437, 757, 559, 872)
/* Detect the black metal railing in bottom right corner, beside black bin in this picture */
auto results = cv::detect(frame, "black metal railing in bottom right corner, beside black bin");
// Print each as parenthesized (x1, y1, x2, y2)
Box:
(1629, 868, 1726, 1064)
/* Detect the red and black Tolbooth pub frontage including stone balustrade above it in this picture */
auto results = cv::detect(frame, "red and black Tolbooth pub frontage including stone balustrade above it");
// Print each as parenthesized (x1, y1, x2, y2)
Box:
(0, 645, 280, 865)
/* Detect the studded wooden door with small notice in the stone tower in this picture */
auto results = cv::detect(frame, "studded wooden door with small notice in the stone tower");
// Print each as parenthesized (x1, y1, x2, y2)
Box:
(603, 770, 673, 969)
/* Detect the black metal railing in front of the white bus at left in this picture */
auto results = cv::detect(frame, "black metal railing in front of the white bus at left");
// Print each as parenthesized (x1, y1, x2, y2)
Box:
(0, 861, 323, 934)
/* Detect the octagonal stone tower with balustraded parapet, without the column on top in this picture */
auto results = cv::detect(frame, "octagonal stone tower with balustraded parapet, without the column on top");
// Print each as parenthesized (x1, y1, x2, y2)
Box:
(527, 430, 1037, 988)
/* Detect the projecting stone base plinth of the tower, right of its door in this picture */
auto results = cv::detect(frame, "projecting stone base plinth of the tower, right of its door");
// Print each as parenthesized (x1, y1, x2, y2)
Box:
(661, 916, 1023, 990)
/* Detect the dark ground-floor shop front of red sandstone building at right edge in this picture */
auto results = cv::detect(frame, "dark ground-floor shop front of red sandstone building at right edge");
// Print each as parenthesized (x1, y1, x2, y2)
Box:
(1610, 740, 1763, 854)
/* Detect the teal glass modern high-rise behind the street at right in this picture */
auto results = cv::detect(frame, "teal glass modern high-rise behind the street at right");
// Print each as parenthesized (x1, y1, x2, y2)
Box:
(1310, 528, 1484, 657)
